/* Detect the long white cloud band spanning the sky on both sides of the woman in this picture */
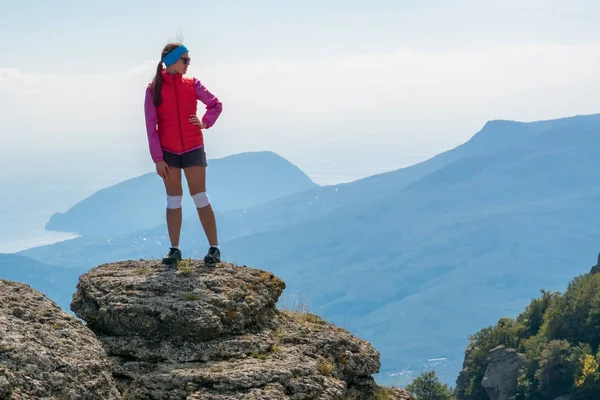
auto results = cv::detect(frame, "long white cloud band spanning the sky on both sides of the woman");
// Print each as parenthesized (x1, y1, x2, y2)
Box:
(0, 43, 600, 155)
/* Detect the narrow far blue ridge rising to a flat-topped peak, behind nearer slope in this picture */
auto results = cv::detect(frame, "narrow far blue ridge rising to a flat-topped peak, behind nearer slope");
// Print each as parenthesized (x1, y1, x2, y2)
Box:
(220, 114, 600, 232)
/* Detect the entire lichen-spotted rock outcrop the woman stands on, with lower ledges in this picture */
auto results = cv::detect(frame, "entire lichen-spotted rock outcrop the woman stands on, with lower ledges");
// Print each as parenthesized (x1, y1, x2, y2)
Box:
(71, 260, 412, 400)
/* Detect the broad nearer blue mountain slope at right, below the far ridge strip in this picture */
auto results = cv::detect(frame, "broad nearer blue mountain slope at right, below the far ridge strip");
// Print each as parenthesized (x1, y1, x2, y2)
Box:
(218, 114, 600, 383)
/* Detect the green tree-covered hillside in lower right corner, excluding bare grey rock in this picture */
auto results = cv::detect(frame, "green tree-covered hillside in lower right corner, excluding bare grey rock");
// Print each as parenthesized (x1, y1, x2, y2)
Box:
(455, 262, 600, 400)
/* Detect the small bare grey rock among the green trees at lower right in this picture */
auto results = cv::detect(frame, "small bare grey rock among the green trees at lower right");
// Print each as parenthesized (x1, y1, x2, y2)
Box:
(481, 346, 524, 400)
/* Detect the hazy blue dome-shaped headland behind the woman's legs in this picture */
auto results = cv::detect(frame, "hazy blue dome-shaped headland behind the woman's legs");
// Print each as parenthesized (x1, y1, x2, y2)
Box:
(46, 151, 318, 237)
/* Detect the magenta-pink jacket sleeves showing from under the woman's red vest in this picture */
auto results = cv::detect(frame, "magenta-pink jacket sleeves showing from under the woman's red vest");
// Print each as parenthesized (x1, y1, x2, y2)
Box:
(144, 78, 223, 163)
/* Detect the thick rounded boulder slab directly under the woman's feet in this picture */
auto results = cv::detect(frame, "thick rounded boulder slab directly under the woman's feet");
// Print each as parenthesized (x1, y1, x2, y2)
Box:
(71, 260, 285, 340)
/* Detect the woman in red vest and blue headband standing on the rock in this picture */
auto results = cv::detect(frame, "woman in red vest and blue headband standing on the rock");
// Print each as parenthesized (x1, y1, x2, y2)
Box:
(144, 43, 223, 265)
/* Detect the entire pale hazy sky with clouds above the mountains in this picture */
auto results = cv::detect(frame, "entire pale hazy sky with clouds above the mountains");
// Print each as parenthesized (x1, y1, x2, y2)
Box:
(0, 0, 600, 184)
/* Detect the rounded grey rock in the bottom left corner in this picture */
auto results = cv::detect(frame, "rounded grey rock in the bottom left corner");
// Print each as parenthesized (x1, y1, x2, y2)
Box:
(0, 279, 121, 400)
